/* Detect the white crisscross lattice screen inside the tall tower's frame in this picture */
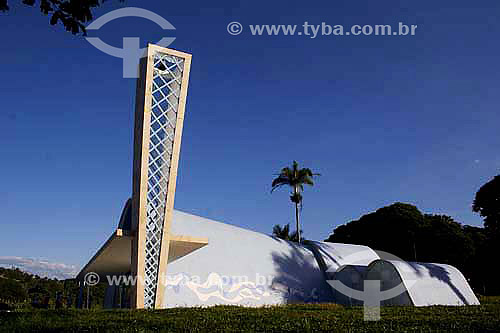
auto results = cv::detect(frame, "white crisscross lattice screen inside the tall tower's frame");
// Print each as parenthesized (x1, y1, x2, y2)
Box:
(144, 52, 184, 308)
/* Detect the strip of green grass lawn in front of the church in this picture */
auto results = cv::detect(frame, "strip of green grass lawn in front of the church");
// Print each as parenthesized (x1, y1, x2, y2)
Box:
(0, 297, 500, 332)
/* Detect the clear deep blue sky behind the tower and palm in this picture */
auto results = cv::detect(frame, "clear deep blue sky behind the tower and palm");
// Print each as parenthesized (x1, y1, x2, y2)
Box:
(0, 0, 500, 265)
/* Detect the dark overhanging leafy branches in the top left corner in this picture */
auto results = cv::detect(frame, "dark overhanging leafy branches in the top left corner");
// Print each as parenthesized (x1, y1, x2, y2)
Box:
(0, 0, 114, 35)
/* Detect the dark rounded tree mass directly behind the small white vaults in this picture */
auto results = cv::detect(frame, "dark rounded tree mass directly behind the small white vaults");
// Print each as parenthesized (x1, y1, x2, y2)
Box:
(326, 203, 499, 294)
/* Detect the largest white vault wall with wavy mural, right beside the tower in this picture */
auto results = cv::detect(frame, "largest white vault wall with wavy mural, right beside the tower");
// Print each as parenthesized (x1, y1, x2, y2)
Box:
(164, 211, 332, 307)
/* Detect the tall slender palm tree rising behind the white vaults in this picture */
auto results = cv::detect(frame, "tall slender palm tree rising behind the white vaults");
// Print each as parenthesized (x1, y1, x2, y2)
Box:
(271, 161, 319, 244)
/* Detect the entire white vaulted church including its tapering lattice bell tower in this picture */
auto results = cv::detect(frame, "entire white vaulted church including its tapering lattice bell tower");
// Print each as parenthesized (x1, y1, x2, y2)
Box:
(77, 45, 478, 308)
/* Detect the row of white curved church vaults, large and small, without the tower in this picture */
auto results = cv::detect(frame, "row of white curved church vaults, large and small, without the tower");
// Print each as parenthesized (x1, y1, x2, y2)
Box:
(158, 211, 479, 307)
